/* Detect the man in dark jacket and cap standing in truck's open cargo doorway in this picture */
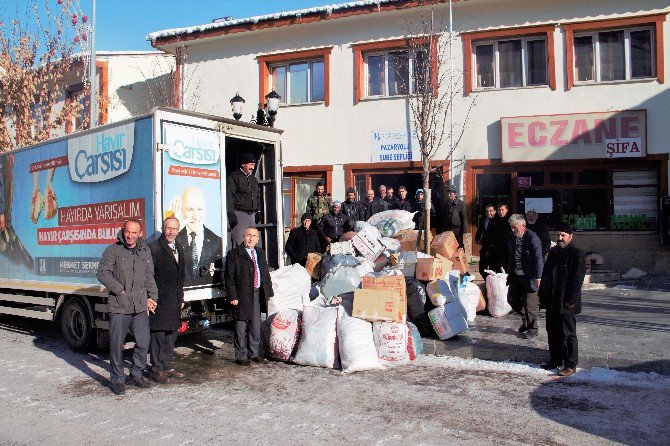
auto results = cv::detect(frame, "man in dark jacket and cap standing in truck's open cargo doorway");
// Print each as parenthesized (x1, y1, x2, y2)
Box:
(226, 152, 259, 247)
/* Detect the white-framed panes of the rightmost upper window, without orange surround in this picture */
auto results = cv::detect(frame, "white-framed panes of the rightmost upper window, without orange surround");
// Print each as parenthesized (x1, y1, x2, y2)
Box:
(573, 28, 654, 82)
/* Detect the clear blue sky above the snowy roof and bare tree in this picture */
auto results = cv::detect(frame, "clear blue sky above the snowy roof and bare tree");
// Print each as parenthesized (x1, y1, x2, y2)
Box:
(0, 0, 348, 51)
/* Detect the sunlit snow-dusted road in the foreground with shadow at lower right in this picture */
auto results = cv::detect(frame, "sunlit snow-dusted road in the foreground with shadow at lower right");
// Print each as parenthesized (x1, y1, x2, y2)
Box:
(0, 317, 670, 446)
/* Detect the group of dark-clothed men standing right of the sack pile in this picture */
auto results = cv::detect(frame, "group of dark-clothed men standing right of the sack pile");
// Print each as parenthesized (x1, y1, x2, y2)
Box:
(475, 203, 586, 376)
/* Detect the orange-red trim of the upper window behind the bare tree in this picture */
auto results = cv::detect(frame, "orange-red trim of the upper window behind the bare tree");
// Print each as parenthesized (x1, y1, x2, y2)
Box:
(351, 34, 440, 105)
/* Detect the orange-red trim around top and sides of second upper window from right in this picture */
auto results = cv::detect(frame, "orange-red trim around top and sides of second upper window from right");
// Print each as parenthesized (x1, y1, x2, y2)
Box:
(461, 25, 556, 95)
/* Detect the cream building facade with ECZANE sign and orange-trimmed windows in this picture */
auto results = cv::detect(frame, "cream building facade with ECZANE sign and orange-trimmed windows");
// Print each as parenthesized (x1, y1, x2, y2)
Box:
(149, 0, 670, 272)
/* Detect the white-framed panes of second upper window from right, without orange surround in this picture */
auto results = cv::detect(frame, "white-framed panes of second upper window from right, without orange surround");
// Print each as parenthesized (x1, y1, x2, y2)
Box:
(474, 37, 548, 88)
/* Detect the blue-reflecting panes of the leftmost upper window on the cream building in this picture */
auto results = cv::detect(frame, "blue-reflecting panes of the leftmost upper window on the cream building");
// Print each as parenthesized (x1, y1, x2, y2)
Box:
(270, 59, 324, 104)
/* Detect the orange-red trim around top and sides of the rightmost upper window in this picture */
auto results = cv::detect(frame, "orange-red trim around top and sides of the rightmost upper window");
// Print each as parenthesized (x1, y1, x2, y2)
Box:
(563, 14, 666, 90)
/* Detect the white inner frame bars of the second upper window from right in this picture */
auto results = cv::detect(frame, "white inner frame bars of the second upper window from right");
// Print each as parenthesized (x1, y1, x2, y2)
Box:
(472, 35, 549, 91)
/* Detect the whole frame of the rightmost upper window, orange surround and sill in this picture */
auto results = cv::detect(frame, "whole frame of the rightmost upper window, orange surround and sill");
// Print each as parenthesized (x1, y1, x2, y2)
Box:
(563, 14, 666, 90)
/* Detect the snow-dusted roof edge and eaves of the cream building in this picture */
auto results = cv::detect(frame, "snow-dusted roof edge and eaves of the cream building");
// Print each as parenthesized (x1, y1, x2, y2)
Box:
(147, 0, 459, 46)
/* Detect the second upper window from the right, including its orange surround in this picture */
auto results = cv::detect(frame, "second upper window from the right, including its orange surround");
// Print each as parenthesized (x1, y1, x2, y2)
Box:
(461, 25, 556, 94)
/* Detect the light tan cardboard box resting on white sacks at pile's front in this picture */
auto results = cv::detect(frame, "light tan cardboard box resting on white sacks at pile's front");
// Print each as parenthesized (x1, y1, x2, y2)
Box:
(352, 289, 406, 322)
